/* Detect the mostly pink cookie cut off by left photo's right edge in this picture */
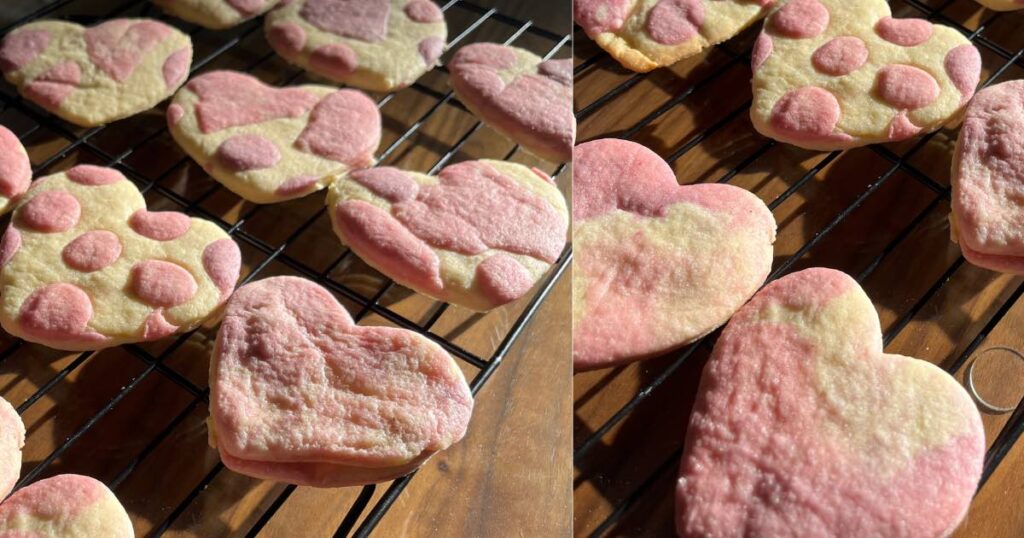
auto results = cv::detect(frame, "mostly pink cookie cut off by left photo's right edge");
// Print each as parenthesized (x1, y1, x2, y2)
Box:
(447, 43, 575, 162)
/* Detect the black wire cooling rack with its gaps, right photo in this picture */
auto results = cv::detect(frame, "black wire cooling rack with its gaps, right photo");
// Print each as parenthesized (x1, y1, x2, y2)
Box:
(573, 0, 1024, 536)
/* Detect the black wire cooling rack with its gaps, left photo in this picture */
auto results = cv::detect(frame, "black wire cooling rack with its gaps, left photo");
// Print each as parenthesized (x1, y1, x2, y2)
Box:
(0, 0, 570, 536)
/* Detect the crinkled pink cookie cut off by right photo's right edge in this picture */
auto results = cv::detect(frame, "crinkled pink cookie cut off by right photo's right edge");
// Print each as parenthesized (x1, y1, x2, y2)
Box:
(949, 80, 1024, 275)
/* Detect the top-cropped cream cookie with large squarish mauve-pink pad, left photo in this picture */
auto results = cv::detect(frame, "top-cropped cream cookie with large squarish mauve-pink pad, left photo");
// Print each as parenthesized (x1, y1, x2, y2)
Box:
(266, 0, 447, 91)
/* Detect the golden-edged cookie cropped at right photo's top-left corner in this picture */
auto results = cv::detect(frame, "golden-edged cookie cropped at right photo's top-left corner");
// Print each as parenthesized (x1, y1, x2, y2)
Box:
(572, 0, 774, 73)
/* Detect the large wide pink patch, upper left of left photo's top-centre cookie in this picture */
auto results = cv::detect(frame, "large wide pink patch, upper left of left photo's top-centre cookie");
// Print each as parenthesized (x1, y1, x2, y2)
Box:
(186, 71, 319, 133)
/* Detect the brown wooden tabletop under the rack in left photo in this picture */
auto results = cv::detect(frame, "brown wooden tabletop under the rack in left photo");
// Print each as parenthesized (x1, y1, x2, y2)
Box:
(0, 0, 571, 537)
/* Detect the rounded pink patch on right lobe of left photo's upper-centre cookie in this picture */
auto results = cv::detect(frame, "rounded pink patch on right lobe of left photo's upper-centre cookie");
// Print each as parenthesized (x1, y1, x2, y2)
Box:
(295, 89, 381, 168)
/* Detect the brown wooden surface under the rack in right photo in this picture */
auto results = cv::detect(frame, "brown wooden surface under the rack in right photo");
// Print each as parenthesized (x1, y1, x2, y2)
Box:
(573, 0, 1024, 538)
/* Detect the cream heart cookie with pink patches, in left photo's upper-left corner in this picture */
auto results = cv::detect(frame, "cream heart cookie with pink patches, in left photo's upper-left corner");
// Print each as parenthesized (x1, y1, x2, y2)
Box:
(0, 18, 191, 126)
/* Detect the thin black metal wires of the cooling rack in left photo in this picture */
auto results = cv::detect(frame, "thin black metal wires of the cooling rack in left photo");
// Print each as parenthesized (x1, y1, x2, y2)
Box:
(0, 0, 571, 536)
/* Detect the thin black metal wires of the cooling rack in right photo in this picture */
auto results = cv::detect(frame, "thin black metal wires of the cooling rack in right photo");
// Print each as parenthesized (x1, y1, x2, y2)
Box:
(573, 0, 1024, 537)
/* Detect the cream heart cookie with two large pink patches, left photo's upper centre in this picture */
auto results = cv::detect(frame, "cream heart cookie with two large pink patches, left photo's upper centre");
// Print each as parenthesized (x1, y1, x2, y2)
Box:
(167, 71, 381, 204)
